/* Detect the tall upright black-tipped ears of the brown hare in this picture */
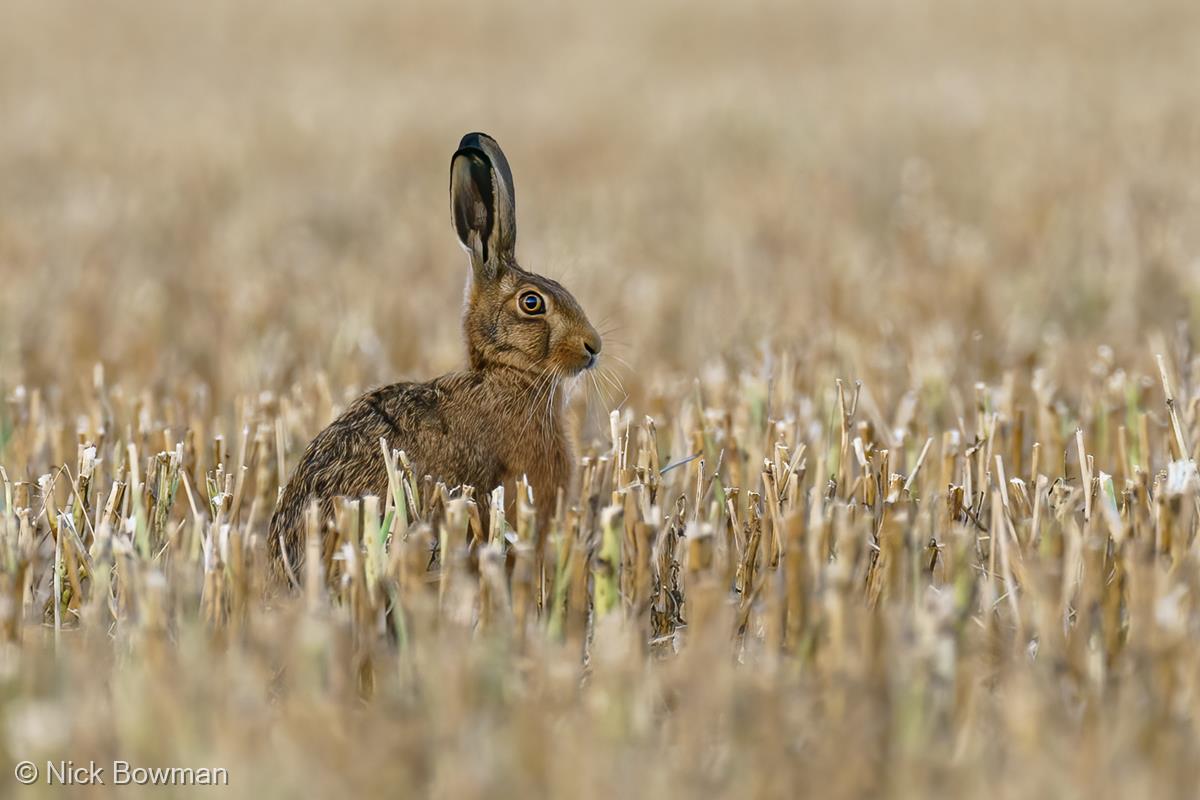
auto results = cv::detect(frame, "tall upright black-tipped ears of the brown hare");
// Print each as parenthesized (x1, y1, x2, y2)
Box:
(450, 133, 517, 278)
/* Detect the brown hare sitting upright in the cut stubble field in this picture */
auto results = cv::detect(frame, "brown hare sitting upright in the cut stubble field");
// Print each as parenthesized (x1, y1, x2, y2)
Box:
(269, 133, 600, 582)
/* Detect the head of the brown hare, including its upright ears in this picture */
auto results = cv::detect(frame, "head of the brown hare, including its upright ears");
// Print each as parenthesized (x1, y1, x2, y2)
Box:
(450, 133, 600, 375)
